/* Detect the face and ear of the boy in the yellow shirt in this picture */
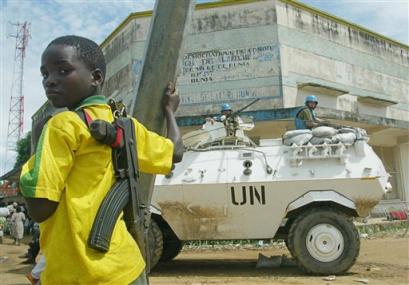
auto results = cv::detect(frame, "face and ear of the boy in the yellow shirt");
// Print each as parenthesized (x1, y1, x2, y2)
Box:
(40, 45, 102, 108)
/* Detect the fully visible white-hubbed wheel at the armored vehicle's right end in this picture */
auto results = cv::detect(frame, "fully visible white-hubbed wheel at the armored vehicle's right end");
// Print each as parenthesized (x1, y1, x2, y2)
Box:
(288, 205, 360, 275)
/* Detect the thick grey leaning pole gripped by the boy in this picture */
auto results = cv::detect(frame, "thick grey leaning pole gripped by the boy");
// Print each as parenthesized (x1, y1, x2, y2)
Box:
(131, 0, 194, 205)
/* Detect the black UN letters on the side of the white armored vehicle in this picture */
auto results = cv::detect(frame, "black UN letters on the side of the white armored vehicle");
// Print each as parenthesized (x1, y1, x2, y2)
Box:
(230, 185, 266, 206)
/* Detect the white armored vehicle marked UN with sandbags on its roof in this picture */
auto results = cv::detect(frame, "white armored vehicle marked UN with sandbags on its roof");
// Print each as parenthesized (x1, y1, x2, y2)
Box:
(150, 117, 390, 274)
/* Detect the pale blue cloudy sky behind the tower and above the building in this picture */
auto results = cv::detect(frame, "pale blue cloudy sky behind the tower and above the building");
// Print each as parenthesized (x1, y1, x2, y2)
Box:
(0, 0, 409, 175)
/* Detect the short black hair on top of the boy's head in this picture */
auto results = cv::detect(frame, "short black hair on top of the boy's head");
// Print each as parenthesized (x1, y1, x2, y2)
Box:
(47, 35, 106, 78)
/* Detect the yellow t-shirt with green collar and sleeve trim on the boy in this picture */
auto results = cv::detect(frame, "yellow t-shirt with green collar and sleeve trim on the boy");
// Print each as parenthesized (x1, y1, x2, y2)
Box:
(20, 96, 173, 285)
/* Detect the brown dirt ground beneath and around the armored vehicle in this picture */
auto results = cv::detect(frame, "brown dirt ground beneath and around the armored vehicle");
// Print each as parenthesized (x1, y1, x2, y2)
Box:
(0, 233, 409, 285)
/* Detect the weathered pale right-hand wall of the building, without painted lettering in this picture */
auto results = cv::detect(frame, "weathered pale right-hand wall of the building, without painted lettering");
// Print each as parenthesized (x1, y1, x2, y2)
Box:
(276, 1, 409, 121)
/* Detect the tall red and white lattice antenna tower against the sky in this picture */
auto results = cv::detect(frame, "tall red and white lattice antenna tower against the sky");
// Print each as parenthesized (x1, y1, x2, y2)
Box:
(5, 22, 30, 171)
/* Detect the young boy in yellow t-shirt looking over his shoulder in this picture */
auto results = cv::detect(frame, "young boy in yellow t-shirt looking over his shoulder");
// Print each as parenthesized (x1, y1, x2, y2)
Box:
(20, 36, 183, 285)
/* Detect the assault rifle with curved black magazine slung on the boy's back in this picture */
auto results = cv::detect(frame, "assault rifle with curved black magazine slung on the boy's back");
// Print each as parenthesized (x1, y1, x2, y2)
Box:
(84, 100, 149, 270)
